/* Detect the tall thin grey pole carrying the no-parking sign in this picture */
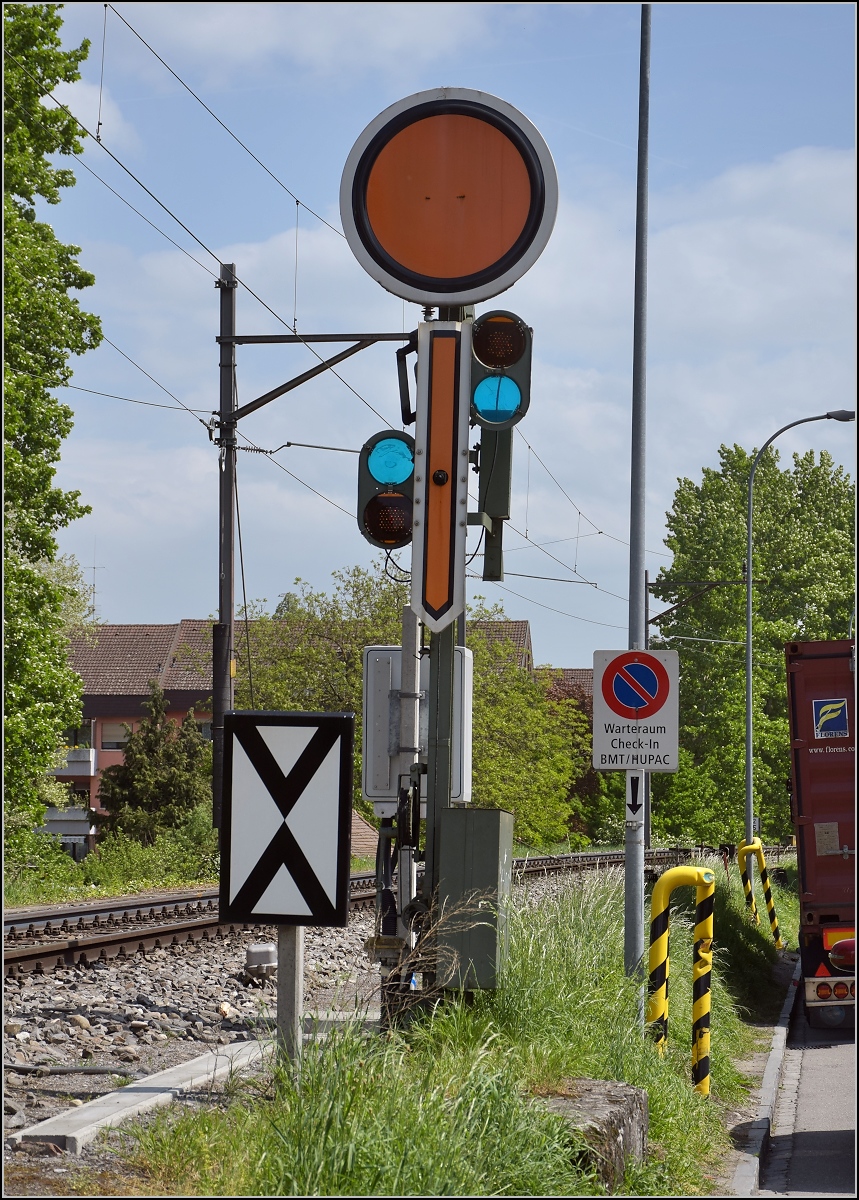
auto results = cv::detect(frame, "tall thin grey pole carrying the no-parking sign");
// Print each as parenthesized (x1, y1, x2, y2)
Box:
(624, 4, 650, 1025)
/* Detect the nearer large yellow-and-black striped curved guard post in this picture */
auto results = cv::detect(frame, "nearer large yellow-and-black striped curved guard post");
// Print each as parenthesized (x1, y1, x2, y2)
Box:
(647, 866, 716, 1096)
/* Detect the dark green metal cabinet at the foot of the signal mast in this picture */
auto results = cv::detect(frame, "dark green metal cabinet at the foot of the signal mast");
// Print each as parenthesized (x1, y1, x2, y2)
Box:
(437, 808, 513, 991)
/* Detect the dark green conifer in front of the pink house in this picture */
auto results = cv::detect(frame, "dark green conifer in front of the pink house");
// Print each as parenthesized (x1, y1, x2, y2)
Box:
(96, 680, 211, 845)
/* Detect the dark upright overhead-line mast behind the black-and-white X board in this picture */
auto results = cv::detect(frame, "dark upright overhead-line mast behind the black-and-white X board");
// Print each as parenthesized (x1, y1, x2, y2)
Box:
(212, 263, 236, 829)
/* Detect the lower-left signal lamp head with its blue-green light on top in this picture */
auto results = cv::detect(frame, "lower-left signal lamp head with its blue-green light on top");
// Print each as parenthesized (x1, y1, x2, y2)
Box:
(358, 430, 415, 550)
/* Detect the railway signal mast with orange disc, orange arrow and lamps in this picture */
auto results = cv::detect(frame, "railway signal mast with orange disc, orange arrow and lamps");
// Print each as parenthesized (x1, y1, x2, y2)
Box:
(340, 88, 558, 988)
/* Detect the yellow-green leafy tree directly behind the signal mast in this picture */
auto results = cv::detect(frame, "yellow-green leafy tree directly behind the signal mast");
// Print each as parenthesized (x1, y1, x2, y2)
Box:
(235, 562, 597, 846)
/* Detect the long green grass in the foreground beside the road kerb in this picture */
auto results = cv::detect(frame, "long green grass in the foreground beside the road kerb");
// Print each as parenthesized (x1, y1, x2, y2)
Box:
(115, 863, 795, 1196)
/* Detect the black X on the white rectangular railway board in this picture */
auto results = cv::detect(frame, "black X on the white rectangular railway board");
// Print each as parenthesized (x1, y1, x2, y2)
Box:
(230, 725, 342, 922)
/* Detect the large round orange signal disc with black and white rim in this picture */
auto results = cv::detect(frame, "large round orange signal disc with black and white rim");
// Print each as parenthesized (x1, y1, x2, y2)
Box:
(341, 89, 558, 304)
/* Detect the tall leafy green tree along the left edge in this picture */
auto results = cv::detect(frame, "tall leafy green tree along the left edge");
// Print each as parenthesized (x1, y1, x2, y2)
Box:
(4, 4, 101, 857)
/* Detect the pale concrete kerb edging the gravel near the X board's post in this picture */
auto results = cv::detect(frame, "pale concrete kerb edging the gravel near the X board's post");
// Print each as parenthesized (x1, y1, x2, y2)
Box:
(6, 1009, 380, 1154)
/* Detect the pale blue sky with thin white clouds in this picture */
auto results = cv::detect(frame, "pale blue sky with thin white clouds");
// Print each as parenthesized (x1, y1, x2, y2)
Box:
(38, 4, 855, 666)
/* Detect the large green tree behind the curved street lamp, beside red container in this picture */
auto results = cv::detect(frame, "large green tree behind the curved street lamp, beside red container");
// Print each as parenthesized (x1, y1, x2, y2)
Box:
(651, 445, 854, 845)
